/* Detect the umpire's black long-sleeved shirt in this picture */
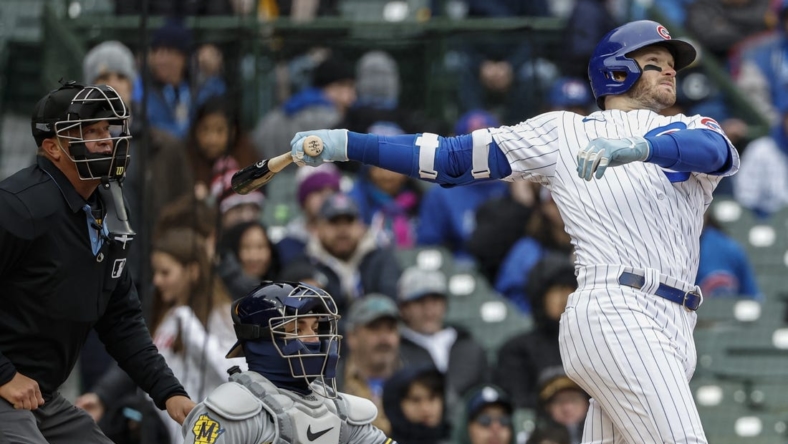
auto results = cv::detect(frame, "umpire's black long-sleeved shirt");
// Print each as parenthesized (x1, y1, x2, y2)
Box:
(0, 156, 186, 409)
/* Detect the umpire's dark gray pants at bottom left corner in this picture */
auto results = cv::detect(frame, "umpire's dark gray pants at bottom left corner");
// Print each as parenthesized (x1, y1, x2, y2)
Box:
(0, 393, 112, 444)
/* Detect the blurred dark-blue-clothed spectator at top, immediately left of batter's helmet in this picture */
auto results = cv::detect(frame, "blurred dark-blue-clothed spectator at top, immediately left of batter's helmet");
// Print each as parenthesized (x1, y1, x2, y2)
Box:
(560, 0, 620, 79)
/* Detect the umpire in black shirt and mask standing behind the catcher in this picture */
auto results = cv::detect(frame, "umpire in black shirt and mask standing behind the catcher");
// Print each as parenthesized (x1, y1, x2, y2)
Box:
(0, 82, 194, 444)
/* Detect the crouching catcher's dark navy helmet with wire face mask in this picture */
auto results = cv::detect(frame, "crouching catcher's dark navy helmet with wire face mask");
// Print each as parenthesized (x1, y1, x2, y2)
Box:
(227, 281, 341, 396)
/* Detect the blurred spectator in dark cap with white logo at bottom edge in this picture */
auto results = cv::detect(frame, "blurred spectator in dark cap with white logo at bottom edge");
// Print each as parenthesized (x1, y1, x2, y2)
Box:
(457, 385, 515, 444)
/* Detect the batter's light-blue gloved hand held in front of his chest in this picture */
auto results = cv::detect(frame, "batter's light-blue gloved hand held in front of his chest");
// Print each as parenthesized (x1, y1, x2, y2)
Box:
(577, 137, 651, 180)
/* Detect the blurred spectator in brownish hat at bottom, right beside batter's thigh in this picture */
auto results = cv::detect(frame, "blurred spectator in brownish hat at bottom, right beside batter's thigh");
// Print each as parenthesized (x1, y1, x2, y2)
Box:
(536, 366, 589, 444)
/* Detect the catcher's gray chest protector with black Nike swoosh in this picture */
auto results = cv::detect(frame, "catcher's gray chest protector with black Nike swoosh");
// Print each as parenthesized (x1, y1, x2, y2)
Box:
(205, 371, 377, 444)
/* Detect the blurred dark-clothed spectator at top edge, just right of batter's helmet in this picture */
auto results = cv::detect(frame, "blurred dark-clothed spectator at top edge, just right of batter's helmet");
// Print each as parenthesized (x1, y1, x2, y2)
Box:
(686, 0, 774, 60)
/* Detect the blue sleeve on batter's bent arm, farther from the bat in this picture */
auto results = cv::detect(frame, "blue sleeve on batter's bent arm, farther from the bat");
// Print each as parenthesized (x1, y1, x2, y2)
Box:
(646, 129, 733, 174)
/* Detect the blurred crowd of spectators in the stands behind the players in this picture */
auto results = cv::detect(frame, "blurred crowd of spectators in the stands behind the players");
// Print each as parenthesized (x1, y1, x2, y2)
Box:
(7, 0, 788, 444)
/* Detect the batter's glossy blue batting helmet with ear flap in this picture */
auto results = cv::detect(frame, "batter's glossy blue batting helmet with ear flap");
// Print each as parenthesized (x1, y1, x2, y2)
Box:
(588, 20, 696, 109)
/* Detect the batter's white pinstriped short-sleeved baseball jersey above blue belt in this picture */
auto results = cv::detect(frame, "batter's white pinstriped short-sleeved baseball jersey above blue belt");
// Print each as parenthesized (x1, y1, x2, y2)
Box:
(490, 110, 739, 282)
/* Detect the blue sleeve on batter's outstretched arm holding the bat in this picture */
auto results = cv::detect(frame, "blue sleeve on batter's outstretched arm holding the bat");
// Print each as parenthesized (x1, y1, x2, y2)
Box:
(347, 131, 512, 186)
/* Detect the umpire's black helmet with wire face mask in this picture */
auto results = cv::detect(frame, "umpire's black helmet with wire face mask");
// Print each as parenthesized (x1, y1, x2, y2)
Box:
(31, 81, 131, 180)
